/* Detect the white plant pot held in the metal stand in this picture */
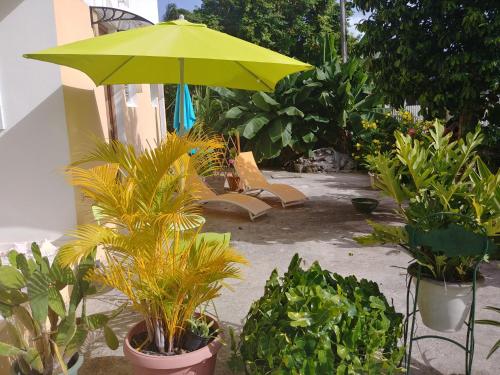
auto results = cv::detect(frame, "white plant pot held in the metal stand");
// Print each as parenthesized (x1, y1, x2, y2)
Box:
(413, 277, 472, 332)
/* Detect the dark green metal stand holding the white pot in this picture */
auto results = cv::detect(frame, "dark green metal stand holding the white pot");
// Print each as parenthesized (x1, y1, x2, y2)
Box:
(403, 217, 495, 375)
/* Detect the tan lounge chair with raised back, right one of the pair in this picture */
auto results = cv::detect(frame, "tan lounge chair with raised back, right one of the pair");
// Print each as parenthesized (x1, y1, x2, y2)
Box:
(234, 151, 307, 207)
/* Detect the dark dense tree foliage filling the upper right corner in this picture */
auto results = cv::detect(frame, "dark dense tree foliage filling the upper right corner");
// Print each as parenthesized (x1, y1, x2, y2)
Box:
(354, 0, 500, 135)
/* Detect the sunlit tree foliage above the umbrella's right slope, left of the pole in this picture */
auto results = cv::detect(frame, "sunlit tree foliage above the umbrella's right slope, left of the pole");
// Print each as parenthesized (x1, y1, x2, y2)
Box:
(193, 0, 350, 64)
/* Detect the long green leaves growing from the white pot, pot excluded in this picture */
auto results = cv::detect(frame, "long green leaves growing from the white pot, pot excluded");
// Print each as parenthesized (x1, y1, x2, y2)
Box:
(356, 121, 500, 281)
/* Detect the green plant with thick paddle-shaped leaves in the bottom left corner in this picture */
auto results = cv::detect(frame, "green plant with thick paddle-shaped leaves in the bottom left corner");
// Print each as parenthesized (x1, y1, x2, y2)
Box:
(0, 243, 125, 375)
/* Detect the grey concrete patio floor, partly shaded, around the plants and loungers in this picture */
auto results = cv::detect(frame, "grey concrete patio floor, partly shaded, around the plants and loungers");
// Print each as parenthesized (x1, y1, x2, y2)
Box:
(79, 172, 500, 375)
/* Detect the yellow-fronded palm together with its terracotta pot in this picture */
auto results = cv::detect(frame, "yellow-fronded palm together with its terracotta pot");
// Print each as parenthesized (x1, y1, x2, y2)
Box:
(58, 133, 246, 375)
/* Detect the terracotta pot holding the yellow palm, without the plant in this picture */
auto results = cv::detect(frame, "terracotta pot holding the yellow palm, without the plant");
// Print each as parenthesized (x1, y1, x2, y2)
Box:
(123, 321, 222, 375)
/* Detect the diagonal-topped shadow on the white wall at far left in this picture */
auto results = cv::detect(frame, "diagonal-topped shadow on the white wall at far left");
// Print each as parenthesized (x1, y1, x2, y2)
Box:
(0, 88, 75, 247)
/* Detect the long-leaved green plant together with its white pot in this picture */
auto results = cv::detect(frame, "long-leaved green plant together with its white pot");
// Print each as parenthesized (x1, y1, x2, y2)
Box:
(356, 121, 500, 332)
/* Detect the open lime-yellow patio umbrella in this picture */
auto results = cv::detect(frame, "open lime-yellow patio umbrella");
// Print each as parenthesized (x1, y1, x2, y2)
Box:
(24, 19, 311, 133)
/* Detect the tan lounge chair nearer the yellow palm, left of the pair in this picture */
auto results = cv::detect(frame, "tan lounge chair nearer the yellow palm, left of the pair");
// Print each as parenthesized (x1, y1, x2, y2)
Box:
(188, 176, 272, 221)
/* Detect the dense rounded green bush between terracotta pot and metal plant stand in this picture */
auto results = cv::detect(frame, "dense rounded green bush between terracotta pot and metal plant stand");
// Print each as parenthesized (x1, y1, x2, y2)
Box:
(236, 254, 403, 374)
